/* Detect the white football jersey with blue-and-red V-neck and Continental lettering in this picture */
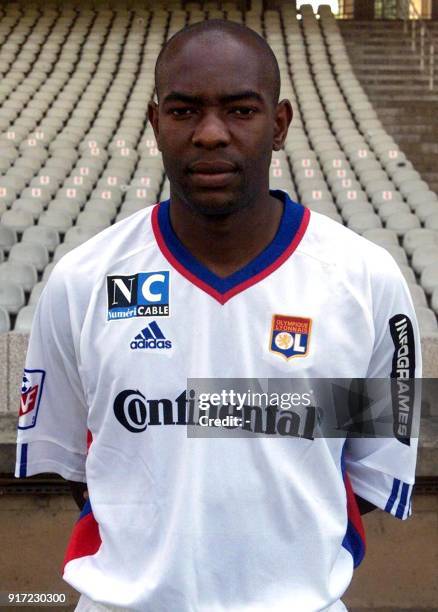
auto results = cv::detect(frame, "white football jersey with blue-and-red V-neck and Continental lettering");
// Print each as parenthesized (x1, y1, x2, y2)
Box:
(16, 192, 421, 612)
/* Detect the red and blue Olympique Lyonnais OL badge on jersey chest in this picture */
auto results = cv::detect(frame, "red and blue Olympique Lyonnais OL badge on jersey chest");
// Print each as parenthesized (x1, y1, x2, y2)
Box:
(270, 315, 312, 359)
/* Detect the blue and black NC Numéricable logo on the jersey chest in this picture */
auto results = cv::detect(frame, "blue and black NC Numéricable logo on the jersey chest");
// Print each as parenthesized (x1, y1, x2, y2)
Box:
(107, 270, 170, 321)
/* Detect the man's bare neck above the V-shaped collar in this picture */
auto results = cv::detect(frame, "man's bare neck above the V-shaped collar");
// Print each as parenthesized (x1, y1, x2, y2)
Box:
(170, 193, 283, 278)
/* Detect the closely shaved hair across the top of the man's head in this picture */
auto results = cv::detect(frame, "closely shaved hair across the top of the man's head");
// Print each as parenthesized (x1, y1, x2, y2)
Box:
(155, 19, 280, 104)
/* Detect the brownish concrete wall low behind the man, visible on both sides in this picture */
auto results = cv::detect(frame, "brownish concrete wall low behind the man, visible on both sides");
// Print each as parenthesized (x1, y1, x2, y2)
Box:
(0, 495, 438, 612)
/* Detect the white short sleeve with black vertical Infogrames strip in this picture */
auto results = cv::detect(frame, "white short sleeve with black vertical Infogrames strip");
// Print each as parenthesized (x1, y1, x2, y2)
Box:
(344, 251, 422, 519)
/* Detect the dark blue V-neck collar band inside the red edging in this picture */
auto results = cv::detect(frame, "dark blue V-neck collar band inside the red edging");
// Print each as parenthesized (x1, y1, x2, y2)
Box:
(158, 190, 305, 293)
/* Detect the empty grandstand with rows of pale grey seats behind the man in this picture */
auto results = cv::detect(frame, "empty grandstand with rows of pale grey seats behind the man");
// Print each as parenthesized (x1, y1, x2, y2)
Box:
(0, 1, 438, 333)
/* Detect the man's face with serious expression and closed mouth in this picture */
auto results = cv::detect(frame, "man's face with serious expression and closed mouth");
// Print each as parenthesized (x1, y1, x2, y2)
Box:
(149, 32, 290, 215)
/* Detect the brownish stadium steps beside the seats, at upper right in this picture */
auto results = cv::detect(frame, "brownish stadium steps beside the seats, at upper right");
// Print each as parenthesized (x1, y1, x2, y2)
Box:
(339, 21, 438, 192)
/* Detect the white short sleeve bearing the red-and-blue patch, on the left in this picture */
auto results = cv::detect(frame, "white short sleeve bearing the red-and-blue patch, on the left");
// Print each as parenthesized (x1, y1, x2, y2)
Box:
(15, 262, 88, 482)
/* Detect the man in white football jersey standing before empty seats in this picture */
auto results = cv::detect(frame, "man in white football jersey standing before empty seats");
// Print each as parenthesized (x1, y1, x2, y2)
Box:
(16, 20, 421, 612)
